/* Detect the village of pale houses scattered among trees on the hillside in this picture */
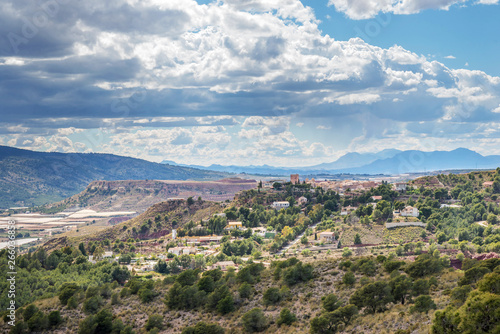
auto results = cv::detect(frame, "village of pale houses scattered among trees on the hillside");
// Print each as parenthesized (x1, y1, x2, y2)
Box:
(78, 174, 438, 276)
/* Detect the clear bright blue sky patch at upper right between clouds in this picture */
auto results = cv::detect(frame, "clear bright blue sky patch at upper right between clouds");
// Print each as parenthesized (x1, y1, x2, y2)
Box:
(303, 0, 500, 76)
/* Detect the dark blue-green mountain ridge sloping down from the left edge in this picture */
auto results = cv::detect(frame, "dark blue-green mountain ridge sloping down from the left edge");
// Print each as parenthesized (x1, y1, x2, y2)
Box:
(0, 146, 228, 208)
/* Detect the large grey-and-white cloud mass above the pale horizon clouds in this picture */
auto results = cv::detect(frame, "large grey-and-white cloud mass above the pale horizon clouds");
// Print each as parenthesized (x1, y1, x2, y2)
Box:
(0, 0, 500, 143)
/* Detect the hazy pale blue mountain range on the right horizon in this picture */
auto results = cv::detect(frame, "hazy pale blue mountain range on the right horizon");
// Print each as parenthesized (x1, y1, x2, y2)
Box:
(162, 148, 500, 176)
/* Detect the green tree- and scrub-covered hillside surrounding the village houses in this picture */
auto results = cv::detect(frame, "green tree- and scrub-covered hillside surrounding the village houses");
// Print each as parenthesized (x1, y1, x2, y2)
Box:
(0, 170, 500, 334)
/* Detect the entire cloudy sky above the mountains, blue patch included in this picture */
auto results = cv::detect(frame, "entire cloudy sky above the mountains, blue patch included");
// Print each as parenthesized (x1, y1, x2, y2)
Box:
(0, 0, 500, 166)
